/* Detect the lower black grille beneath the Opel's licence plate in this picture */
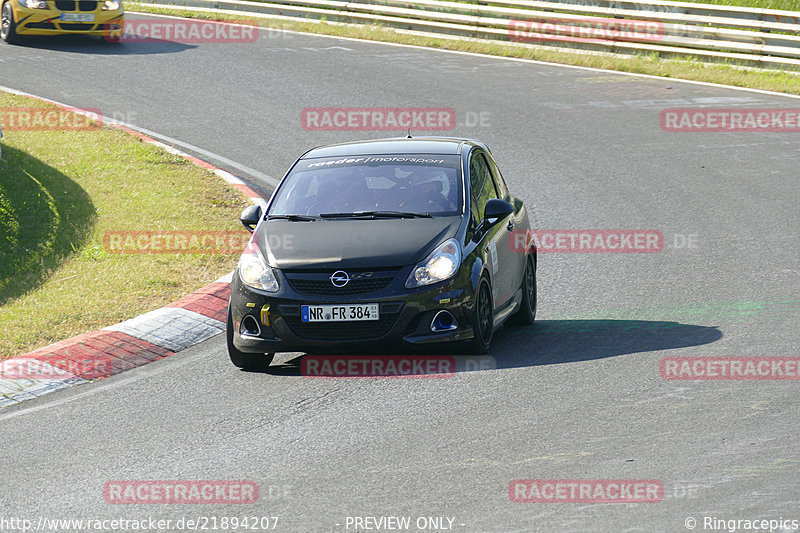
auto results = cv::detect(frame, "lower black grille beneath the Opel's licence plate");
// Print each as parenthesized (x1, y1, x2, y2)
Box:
(280, 302, 403, 341)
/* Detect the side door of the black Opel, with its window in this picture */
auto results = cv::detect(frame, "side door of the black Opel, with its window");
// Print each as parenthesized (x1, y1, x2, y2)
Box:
(469, 149, 510, 309)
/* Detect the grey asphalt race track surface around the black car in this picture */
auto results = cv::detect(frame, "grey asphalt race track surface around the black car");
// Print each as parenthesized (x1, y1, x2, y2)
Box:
(0, 13, 800, 532)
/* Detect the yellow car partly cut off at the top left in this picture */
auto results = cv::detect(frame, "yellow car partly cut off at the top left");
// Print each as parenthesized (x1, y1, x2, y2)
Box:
(0, 0, 125, 43)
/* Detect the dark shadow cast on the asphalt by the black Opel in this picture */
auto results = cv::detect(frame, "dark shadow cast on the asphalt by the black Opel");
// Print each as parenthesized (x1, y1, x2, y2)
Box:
(258, 320, 722, 376)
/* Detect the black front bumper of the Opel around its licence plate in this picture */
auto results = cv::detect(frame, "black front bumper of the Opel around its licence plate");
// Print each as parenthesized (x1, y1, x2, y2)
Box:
(230, 267, 474, 353)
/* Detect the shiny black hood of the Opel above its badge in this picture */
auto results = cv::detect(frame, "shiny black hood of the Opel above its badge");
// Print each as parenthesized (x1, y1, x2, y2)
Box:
(257, 216, 462, 269)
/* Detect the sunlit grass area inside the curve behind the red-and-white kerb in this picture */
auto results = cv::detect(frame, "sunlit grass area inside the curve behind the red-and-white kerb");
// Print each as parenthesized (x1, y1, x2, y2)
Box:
(0, 92, 247, 359)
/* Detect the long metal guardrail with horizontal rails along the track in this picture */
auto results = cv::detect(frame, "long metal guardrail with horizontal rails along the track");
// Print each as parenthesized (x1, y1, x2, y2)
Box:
(128, 0, 800, 70)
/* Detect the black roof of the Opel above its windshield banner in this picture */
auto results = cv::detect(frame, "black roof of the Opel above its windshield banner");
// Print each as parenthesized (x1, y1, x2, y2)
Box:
(300, 137, 489, 159)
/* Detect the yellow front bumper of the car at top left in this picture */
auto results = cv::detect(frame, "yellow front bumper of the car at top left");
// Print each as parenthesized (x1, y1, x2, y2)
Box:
(11, 0, 125, 38)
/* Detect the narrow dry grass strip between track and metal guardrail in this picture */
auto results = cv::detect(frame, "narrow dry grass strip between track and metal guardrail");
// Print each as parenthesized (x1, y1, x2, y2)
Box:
(126, 3, 800, 94)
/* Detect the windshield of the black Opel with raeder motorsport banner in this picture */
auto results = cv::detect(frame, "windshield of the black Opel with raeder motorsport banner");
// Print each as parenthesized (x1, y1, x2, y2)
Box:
(269, 154, 462, 218)
